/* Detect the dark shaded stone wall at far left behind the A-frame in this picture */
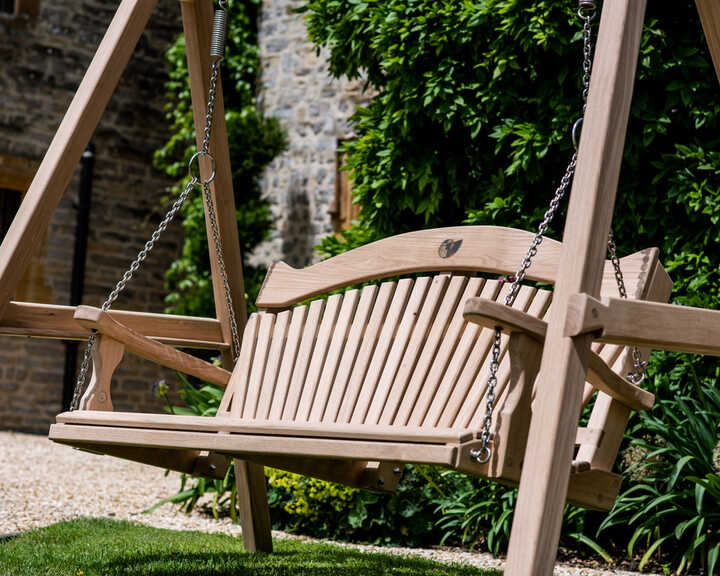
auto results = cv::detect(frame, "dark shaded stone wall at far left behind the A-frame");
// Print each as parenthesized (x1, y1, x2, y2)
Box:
(0, 0, 186, 432)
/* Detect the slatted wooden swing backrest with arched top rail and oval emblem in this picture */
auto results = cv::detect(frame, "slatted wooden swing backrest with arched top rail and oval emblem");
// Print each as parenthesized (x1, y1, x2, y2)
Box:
(218, 226, 669, 454)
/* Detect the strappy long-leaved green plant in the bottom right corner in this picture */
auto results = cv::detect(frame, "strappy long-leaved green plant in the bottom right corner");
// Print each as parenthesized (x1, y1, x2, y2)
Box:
(598, 383, 720, 574)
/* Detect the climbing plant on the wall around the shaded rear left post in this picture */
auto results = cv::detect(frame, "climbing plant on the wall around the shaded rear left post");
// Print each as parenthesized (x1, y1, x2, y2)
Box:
(155, 0, 286, 316)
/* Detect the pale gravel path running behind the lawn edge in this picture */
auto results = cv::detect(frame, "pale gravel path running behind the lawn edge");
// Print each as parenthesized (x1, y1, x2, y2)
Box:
(0, 432, 647, 576)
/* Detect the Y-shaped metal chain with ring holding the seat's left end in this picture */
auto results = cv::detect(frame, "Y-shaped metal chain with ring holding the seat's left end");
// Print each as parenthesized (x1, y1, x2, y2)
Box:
(70, 1, 235, 410)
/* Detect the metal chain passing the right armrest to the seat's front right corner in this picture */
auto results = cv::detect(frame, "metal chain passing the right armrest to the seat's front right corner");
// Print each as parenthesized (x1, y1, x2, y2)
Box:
(470, 0, 595, 464)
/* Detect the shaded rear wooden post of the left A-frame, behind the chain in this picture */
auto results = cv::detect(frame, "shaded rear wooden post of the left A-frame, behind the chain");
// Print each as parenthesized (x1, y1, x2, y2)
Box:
(181, 0, 272, 552)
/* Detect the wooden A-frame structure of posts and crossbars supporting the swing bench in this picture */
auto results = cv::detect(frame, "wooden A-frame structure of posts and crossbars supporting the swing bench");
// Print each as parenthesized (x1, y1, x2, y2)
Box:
(0, 0, 720, 576)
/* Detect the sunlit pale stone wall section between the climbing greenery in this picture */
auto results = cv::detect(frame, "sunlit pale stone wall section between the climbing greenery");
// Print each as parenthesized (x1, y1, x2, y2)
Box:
(252, 0, 366, 266)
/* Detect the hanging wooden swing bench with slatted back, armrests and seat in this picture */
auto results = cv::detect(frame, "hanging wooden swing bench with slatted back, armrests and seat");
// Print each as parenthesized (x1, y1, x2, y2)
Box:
(50, 226, 670, 509)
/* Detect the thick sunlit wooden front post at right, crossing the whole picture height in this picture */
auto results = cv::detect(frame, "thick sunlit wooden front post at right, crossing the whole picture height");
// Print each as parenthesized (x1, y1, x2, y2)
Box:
(505, 0, 646, 576)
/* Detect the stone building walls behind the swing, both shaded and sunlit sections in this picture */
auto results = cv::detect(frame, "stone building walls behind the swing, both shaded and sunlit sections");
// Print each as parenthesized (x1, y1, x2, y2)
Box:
(0, 0, 365, 433)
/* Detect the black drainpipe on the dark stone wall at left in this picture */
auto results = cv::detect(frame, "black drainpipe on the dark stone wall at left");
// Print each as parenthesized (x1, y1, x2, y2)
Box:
(62, 142, 95, 411)
